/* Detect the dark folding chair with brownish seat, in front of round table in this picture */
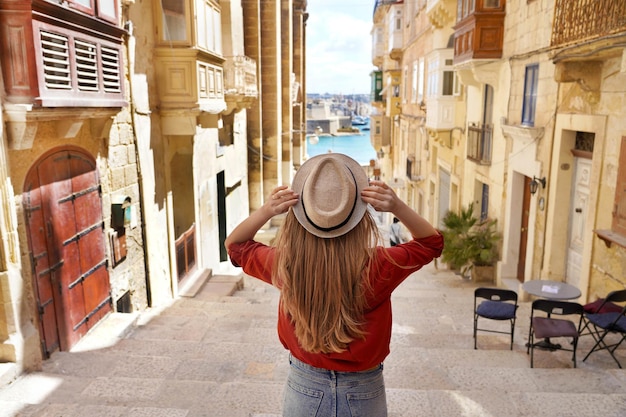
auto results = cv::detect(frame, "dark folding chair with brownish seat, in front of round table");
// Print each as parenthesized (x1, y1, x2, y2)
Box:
(526, 299, 584, 368)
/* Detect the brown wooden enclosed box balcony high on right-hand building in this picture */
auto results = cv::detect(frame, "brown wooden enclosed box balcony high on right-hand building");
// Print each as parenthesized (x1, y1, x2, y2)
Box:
(454, 0, 506, 65)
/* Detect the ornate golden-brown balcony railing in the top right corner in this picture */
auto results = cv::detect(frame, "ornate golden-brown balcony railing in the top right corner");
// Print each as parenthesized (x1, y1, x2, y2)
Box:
(551, 0, 626, 46)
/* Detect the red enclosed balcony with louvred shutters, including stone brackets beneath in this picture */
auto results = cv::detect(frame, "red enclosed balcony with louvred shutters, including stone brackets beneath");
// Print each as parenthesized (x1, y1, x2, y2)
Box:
(0, 0, 127, 150)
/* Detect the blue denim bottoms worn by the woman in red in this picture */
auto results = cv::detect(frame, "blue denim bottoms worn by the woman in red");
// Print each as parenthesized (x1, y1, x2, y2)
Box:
(283, 355, 387, 417)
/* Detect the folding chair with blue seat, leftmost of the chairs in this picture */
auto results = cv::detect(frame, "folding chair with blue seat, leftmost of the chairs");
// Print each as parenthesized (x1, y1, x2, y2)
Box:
(474, 287, 518, 350)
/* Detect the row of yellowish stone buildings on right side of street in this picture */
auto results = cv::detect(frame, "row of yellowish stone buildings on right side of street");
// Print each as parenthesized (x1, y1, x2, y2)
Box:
(372, 0, 626, 302)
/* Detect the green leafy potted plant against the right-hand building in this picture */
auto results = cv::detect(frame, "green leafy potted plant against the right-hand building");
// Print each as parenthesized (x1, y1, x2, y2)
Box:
(441, 204, 500, 281)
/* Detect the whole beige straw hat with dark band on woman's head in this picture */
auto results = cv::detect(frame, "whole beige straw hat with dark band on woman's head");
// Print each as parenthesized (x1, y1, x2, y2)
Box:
(291, 153, 368, 238)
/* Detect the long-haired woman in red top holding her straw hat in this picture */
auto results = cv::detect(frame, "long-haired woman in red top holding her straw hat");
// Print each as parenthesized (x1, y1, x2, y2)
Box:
(225, 153, 443, 417)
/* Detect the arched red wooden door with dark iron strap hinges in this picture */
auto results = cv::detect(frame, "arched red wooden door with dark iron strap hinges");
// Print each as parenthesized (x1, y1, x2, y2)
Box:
(24, 149, 111, 355)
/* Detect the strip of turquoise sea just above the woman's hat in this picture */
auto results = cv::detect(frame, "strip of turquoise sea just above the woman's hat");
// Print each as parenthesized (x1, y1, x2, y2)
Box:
(307, 125, 376, 165)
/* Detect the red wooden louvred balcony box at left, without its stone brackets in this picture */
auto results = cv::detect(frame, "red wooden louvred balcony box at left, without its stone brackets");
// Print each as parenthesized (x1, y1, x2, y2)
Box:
(0, 0, 126, 110)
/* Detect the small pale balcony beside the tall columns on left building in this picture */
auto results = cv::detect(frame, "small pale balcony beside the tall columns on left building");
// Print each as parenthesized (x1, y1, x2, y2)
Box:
(224, 55, 259, 113)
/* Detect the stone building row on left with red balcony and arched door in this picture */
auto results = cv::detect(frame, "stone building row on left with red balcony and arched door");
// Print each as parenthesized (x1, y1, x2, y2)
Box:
(0, 0, 306, 375)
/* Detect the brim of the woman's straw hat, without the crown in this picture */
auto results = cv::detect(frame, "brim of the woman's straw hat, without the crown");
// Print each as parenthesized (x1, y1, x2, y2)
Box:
(291, 153, 369, 238)
